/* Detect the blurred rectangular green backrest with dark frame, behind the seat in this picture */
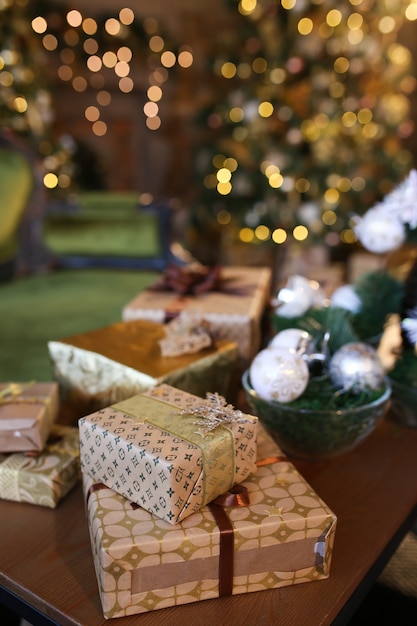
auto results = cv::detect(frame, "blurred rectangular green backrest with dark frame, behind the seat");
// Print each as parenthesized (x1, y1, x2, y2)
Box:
(42, 192, 171, 270)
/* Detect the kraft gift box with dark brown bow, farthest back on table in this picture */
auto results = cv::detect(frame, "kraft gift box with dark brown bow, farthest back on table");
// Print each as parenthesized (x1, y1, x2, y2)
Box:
(122, 265, 272, 369)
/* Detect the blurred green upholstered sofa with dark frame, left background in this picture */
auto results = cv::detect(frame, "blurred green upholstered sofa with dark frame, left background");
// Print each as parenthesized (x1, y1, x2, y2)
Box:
(0, 138, 175, 382)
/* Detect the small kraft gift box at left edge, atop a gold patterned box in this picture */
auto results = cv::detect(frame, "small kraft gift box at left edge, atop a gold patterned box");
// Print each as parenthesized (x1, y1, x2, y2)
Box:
(0, 382, 59, 452)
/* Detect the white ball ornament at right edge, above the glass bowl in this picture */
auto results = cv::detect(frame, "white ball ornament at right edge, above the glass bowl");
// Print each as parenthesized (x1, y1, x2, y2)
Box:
(354, 204, 406, 254)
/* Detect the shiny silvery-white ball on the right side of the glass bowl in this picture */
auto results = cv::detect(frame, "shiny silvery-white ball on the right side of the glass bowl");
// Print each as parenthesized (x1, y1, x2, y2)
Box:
(329, 341, 385, 390)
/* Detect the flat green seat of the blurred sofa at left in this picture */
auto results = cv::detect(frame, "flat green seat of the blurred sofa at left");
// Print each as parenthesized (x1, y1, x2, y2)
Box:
(0, 268, 160, 382)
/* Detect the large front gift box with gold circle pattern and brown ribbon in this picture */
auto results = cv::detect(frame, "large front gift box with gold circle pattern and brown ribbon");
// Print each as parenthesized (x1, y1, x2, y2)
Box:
(83, 425, 336, 621)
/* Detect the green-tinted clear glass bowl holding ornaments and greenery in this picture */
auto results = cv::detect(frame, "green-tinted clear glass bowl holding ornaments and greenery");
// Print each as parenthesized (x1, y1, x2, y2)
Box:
(242, 370, 391, 460)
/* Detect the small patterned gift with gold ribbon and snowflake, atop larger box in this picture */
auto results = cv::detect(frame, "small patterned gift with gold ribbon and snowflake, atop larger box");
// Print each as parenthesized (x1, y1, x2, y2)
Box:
(79, 385, 258, 524)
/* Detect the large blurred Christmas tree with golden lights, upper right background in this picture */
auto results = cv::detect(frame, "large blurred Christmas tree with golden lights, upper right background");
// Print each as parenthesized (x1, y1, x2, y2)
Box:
(190, 0, 417, 260)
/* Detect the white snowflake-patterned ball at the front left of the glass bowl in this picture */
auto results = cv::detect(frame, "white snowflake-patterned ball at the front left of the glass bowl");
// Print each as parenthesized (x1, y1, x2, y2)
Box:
(249, 347, 309, 403)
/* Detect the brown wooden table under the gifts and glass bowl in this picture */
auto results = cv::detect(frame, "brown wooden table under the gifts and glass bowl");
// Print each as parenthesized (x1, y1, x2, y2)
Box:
(0, 410, 417, 626)
